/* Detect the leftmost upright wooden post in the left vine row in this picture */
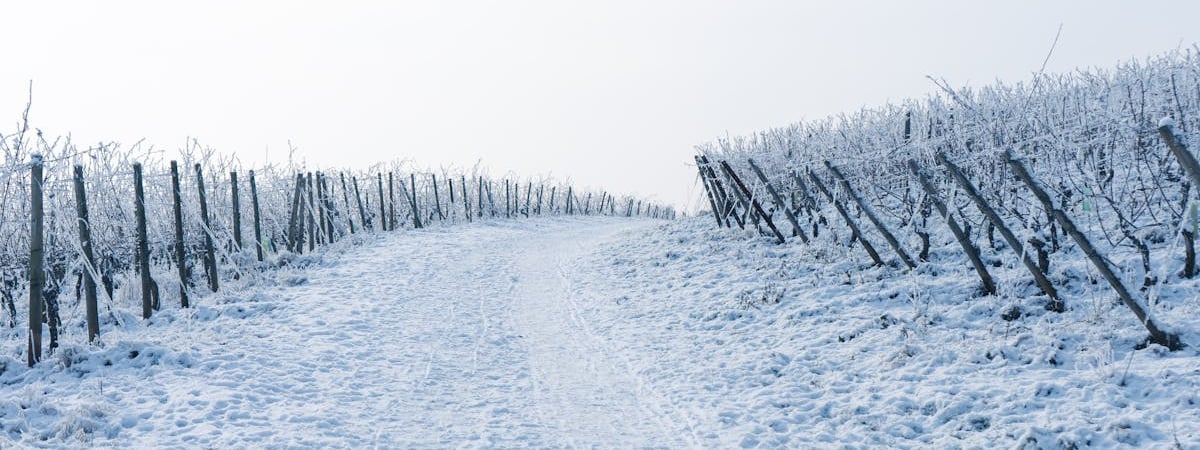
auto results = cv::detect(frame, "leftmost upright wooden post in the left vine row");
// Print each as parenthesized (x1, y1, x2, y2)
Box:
(28, 154, 46, 367)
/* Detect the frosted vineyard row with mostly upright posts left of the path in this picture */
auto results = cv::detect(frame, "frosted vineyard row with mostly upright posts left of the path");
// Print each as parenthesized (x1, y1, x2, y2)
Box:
(0, 107, 676, 366)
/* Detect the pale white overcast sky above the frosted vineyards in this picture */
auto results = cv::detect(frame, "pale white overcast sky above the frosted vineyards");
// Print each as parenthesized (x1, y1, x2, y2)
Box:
(0, 0, 1200, 209)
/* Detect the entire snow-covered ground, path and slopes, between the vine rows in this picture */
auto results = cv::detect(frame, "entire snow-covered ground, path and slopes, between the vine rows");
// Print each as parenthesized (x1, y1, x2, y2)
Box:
(0, 217, 1200, 449)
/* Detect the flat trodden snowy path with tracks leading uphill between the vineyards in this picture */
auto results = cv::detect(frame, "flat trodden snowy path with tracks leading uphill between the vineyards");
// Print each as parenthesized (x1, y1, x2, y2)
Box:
(18, 220, 696, 448)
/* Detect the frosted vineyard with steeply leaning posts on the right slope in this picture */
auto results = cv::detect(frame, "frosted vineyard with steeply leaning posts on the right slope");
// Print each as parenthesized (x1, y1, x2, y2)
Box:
(696, 50, 1200, 349)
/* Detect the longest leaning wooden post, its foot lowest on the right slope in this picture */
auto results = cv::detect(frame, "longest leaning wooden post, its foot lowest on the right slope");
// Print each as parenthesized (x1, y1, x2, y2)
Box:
(1004, 150, 1183, 350)
